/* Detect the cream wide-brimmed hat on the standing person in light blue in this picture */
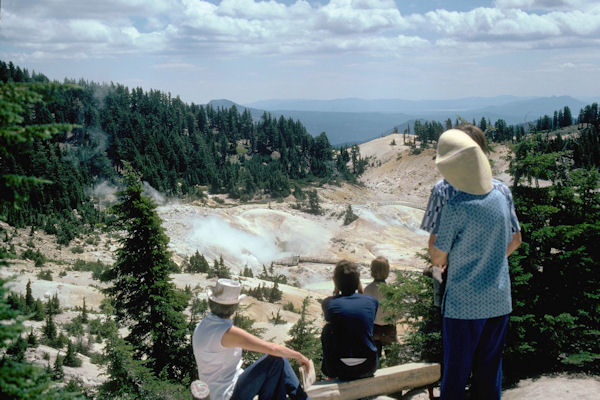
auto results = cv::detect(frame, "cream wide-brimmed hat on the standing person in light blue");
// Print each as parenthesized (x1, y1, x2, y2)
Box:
(435, 129, 492, 195)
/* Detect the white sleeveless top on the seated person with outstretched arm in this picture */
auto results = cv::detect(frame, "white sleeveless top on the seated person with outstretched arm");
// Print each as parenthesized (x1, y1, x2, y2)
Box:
(192, 313, 244, 400)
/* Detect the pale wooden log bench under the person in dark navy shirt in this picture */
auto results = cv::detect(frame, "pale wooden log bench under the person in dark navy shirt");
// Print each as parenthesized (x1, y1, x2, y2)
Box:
(301, 363, 441, 400)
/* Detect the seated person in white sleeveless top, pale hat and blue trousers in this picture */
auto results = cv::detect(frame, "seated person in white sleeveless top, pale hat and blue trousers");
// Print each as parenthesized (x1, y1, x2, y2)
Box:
(192, 279, 309, 400)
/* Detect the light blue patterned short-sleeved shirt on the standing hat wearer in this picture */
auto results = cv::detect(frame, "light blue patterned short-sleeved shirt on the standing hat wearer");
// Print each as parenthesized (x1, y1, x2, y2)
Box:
(434, 188, 513, 319)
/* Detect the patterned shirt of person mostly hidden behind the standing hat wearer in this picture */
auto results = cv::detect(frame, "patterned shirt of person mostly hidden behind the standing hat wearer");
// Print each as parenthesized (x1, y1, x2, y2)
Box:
(421, 179, 521, 235)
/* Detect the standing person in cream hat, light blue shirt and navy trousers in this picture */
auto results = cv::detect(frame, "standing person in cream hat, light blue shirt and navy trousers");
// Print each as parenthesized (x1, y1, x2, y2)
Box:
(429, 129, 520, 400)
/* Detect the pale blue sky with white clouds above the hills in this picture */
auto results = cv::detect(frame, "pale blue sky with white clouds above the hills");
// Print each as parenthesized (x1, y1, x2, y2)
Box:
(0, 0, 600, 104)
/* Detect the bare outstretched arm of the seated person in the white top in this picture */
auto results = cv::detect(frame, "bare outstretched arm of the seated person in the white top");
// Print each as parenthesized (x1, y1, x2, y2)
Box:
(221, 326, 310, 372)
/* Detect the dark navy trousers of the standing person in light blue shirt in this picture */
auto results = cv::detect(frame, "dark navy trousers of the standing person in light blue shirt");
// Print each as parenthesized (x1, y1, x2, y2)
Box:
(440, 315, 508, 400)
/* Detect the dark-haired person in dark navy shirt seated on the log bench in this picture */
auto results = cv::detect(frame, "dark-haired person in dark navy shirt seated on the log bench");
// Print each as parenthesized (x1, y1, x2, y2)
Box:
(321, 260, 379, 380)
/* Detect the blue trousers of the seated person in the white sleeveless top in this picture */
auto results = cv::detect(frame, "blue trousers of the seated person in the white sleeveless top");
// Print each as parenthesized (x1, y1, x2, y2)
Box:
(231, 355, 308, 400)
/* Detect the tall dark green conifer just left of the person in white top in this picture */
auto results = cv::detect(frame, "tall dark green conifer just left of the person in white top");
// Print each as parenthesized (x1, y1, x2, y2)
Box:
(106, 171, 193, 379)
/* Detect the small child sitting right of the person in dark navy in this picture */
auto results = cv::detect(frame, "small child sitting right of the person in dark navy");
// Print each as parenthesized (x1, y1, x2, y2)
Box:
(365, 257, 398, 358)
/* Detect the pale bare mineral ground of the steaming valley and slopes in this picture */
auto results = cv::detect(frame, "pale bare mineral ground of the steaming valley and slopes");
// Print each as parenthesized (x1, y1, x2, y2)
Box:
(0, 134, 600, 399)
